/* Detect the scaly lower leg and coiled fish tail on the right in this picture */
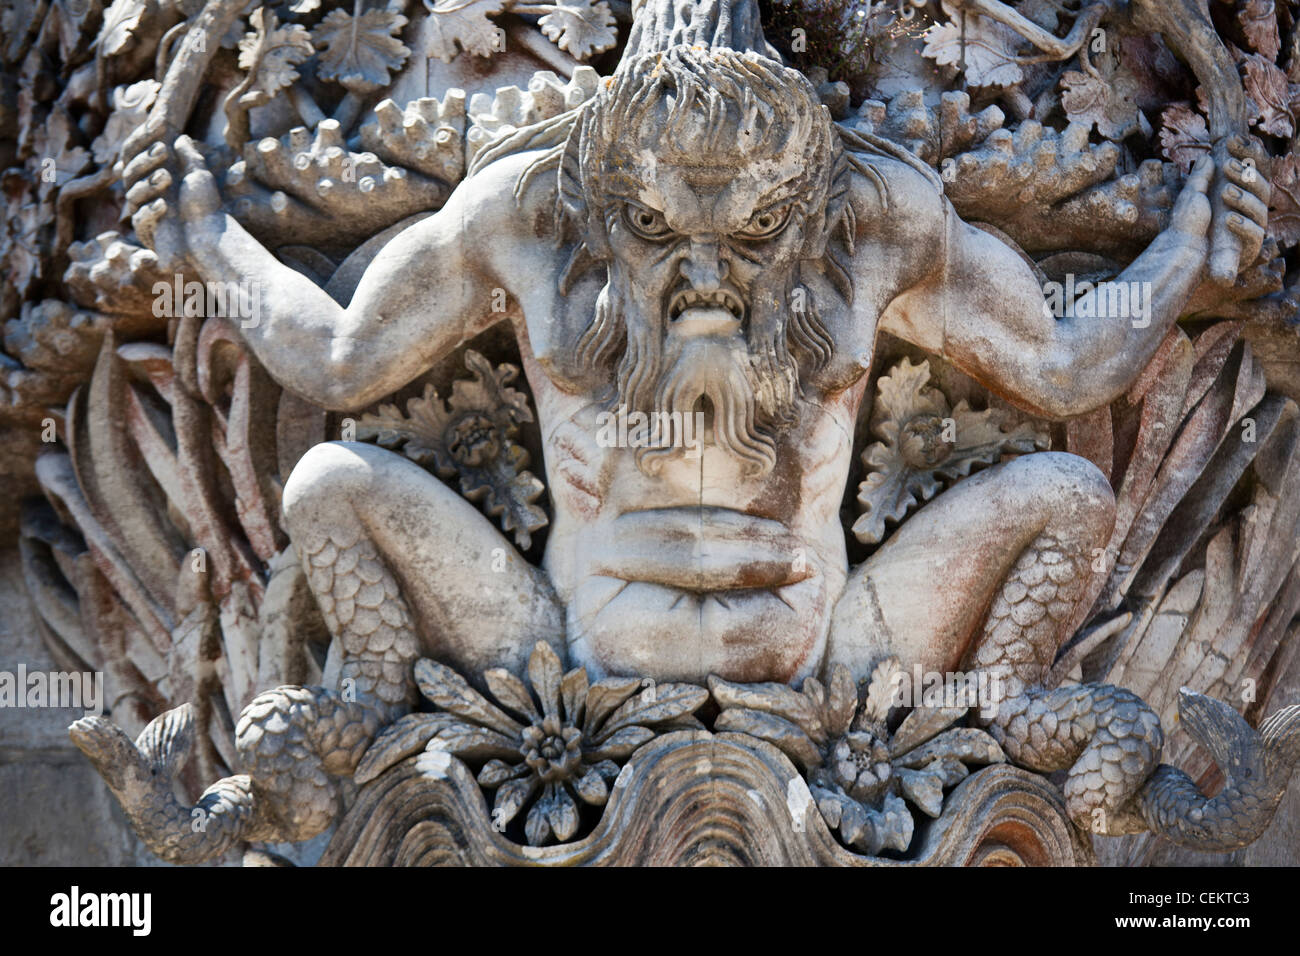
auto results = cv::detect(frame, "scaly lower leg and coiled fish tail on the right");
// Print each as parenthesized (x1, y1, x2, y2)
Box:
(972, 535, 1300, 851)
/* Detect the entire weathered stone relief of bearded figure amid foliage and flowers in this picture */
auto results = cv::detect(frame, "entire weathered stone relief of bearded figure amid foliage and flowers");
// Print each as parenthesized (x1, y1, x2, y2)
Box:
(5, 0, 1300, 864)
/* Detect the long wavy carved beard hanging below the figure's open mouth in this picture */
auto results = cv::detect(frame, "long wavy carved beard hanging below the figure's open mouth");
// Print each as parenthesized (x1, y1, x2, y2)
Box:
(577, 277, 806, 475)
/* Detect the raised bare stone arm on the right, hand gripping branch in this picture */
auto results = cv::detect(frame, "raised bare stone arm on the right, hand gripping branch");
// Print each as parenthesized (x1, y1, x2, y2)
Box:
(881, 143, 1269, 419)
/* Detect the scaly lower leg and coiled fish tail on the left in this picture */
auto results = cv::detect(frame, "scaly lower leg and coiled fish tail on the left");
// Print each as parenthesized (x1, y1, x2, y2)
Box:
(69, 536, 419, 864)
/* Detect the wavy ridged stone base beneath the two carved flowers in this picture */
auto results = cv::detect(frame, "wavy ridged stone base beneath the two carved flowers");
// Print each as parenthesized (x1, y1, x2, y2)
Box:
(319, 731, 1093, 866)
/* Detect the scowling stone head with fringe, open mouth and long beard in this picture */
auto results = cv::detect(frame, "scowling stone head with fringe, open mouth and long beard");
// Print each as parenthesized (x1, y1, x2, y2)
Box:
(579, 47, 836, 473)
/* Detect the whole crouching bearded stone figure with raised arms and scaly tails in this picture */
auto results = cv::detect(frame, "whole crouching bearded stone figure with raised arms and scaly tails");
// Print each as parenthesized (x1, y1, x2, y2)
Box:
(73, 0, 1300, 861)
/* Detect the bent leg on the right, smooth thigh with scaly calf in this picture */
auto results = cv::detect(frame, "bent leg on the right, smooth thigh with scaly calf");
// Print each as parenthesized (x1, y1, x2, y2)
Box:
(828, 451, 1114, 679)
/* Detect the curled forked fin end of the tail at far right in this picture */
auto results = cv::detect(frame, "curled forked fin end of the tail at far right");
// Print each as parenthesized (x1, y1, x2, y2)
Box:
(1135, 687, 1300, 851)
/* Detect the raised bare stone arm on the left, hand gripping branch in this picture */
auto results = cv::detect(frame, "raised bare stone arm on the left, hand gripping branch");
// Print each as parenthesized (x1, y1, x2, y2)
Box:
(124, 128, 519, 411)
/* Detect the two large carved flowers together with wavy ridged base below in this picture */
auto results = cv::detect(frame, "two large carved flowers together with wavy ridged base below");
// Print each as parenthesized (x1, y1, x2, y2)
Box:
(320, 641, 1092, 866)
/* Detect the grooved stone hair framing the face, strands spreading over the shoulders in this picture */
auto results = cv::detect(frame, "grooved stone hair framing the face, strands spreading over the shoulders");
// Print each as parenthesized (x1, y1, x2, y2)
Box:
(467, 44, 943, 382)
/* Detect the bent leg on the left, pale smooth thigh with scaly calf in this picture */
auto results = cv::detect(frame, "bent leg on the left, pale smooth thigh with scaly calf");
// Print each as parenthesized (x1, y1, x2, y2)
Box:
(283, 442, 563, 686)
